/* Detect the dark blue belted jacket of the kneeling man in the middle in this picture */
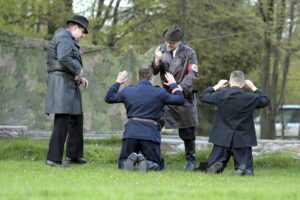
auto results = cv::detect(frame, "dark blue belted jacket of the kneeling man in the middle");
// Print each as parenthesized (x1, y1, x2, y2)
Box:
(105, 80, 184, 142)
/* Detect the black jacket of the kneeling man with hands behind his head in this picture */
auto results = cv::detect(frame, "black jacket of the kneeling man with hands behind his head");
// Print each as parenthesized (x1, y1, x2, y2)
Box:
(200, 87, 270, 148)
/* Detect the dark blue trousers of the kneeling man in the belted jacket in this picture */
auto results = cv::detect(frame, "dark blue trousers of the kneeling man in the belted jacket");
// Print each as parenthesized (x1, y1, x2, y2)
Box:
(119, 139, 165, 170)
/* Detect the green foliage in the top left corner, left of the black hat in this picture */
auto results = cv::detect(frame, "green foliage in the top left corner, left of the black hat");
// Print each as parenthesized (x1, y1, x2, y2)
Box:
(0, 0, 73, 39)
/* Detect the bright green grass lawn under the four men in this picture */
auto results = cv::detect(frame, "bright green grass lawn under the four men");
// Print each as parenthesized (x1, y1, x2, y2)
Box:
(0, 138, 300, 200)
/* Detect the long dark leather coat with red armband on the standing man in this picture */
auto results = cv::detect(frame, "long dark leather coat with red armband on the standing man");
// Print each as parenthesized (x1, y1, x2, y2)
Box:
(150, 44, 198, 129)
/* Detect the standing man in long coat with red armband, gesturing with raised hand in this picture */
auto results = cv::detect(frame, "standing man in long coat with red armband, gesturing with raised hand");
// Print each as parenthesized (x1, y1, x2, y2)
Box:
(150, 25, 198, 170)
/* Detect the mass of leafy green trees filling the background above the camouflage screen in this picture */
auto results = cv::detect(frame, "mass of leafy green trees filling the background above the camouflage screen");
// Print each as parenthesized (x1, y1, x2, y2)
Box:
(0, 0, 300, 138)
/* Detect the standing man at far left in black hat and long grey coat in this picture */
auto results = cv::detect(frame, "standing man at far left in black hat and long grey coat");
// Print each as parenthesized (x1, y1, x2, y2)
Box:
(45, 15, 89, 166)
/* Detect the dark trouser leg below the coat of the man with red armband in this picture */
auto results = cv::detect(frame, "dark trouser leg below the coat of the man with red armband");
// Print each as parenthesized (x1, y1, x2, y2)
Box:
(178, 127, 196, 162)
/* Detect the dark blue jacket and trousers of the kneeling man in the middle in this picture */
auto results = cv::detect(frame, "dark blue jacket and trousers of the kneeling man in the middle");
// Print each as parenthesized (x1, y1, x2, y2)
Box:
(105, 80, 184, 170)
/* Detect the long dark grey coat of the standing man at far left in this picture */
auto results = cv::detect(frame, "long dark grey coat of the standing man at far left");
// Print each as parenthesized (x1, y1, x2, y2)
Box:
(45, 29, 83, 115)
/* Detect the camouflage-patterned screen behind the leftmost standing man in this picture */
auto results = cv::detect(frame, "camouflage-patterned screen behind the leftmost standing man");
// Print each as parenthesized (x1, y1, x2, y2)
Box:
(0, 30, 154, 133)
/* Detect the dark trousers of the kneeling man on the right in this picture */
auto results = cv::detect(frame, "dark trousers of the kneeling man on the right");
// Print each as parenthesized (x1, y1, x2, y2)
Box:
(208, 145, 253, 172)
